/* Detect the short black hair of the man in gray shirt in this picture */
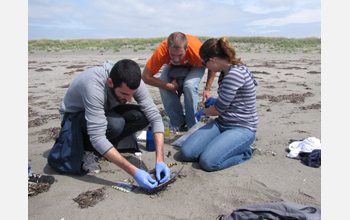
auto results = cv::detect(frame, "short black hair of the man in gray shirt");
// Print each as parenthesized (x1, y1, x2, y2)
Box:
(109, 59, 141, 90)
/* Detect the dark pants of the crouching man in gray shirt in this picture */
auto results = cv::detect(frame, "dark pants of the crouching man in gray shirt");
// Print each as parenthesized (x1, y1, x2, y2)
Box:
(72, 104, 149, 155)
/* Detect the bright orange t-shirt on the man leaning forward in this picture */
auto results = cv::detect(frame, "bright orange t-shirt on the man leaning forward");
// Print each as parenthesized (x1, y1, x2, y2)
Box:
(146, 34, 203, 74)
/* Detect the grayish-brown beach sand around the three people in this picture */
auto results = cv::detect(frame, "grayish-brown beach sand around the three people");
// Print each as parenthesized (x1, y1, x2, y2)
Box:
(28, 45, 321, 219)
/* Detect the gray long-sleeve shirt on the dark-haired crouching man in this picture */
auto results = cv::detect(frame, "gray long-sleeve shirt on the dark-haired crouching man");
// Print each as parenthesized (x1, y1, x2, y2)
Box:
(59, 61, 164, 155)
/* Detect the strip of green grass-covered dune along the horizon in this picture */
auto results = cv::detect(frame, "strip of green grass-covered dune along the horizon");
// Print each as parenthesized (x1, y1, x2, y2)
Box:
(28, 36, 321, 53)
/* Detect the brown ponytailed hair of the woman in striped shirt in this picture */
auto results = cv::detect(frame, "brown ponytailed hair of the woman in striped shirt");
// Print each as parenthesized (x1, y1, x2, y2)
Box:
(199, 37, 245, 65)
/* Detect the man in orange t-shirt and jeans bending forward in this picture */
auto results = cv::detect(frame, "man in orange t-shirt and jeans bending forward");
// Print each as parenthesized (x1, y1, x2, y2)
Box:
(142, 32, 215, 132)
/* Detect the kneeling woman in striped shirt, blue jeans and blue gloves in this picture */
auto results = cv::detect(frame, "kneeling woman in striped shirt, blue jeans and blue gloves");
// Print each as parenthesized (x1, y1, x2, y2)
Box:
(180, 37, 258, 171)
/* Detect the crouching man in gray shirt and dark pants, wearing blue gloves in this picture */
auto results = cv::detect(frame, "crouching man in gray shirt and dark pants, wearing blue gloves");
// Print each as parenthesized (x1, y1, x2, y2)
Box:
(59, 59, 170, 189)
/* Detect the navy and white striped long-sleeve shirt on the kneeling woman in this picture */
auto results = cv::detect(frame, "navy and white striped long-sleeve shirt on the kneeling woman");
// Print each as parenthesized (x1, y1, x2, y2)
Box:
(214, 65, 258, 131)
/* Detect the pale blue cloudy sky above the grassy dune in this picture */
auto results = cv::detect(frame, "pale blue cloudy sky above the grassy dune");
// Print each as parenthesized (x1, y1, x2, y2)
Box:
(28, 0, 321, 40)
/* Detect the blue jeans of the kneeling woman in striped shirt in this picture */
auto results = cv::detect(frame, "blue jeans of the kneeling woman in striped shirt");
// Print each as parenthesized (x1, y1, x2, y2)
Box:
(180, 120, 255, 171)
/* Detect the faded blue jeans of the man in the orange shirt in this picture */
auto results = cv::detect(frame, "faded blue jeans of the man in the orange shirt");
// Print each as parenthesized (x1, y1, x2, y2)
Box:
(159, 65, 205, 128)
